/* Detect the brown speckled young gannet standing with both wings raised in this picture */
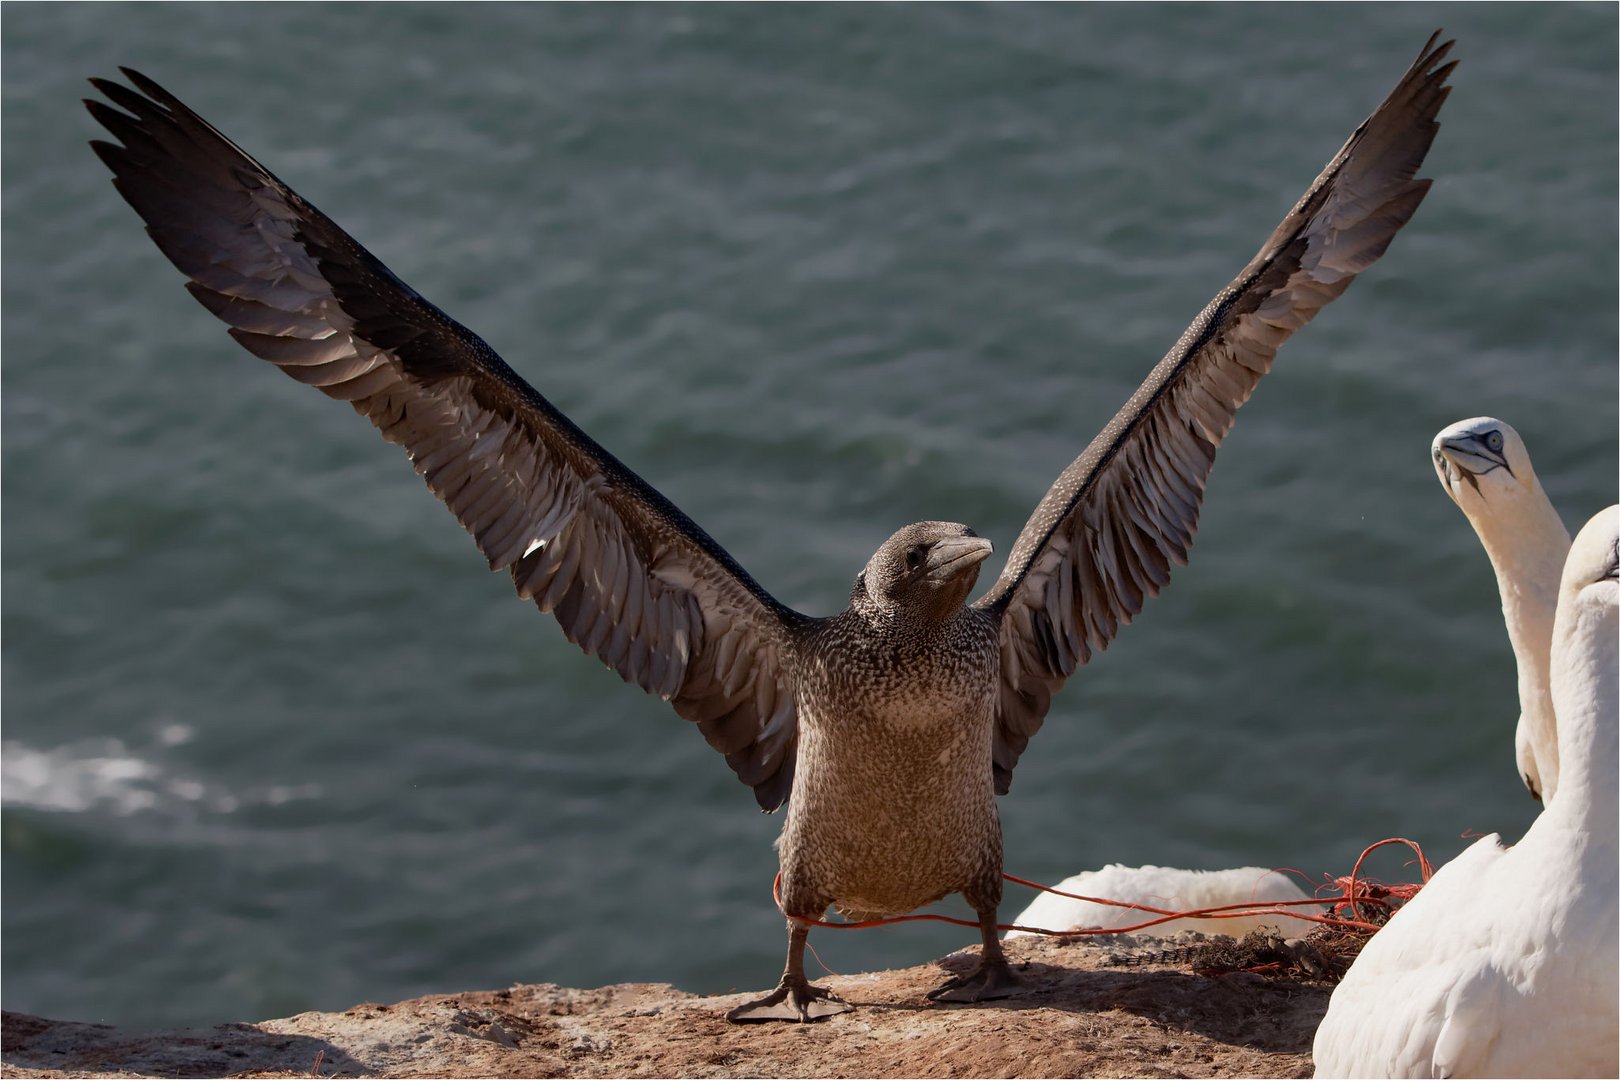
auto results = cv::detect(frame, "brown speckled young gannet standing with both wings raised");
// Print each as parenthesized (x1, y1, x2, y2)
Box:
(86, 37, 1455, 1020)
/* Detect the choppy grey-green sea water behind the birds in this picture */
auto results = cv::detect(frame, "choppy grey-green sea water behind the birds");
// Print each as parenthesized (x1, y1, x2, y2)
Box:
(0, 5, 1617, 1023)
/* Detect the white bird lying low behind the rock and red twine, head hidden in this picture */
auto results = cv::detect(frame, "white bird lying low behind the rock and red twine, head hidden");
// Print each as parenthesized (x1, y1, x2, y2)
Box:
(1008, 863, 1317, 938)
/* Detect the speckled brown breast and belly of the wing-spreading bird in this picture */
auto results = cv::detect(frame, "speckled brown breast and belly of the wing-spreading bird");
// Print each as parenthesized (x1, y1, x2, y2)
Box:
(778, 609, 1001, 918)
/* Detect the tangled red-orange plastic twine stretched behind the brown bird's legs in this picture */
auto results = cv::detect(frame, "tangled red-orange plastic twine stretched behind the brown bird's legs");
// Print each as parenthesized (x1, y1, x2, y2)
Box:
(771, 837, 1434, 938)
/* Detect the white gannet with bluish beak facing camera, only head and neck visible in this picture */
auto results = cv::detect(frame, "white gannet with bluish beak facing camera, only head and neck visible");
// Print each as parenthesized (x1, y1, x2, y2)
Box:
(1430, 416, 1570, 805)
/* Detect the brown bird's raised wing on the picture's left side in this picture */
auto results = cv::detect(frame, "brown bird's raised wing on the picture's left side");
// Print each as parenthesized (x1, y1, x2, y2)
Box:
(86, 68, 807, 810)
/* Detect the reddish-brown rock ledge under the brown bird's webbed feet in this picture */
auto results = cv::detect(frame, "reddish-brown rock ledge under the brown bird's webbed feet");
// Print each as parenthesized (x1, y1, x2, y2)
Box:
(0, 939, 1328, 1077)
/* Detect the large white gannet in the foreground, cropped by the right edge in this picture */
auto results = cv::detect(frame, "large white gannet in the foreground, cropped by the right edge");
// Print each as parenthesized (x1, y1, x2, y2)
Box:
(1314, 507, 1620, 1077)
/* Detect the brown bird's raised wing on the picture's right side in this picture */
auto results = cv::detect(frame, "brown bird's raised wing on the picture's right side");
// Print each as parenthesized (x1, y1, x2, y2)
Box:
(975, 34, 1456, 793)
